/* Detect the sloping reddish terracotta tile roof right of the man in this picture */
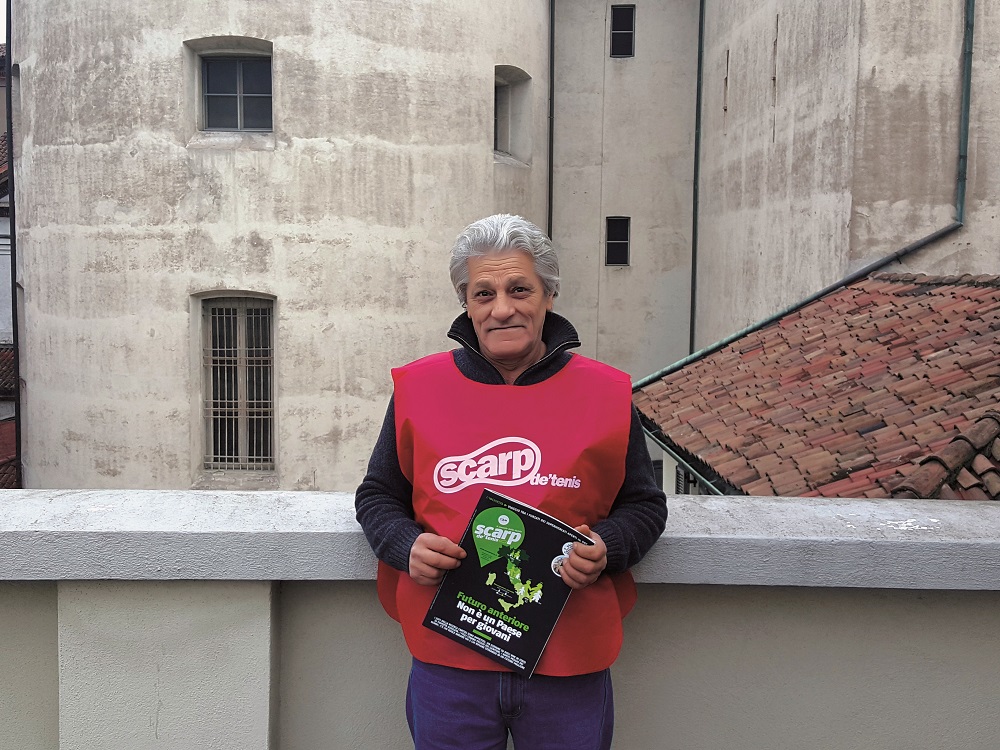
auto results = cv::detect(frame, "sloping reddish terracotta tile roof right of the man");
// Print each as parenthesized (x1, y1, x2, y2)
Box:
(635, 274, 1000, 499)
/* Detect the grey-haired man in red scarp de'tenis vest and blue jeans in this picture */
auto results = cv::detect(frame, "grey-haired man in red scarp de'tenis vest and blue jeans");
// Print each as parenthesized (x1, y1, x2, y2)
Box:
(356, 214, 666, 750)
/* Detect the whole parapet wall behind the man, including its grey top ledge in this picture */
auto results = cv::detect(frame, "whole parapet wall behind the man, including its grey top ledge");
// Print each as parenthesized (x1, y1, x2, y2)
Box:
(0, 490, 1000, 750)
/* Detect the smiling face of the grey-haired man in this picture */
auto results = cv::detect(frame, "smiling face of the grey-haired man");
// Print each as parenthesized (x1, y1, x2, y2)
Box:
(465, 250, 552, 366)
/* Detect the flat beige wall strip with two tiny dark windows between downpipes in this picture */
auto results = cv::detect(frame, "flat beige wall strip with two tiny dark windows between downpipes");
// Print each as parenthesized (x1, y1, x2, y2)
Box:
(552, 0, 698, 379)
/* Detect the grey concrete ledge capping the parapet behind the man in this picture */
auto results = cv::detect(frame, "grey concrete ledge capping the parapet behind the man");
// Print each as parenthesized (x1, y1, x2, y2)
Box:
(0, 490, 1000, 590)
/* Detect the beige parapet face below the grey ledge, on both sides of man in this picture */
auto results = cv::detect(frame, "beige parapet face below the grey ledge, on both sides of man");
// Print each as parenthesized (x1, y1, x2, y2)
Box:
(9, 582, 1000, 750)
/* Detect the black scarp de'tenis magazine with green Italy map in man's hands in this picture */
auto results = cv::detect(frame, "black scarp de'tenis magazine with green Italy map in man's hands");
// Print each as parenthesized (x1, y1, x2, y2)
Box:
(424, 489, 594, 677)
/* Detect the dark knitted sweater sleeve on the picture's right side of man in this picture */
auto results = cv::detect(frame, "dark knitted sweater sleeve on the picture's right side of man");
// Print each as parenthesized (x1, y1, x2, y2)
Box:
(593, 406, 667, 573)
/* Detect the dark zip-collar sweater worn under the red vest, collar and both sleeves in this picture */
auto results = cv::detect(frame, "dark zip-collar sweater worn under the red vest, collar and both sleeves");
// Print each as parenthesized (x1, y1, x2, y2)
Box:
(355, 312, 667, 573)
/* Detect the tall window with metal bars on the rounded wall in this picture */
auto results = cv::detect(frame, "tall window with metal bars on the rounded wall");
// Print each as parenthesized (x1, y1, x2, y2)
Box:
(202, 297, 274, 471)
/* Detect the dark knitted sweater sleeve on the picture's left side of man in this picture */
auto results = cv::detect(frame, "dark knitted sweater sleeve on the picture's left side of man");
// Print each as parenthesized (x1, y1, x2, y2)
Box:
(354, 399, 423, 572)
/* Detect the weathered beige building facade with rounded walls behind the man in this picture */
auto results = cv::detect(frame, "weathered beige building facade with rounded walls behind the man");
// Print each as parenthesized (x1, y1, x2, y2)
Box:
(11, 0, 1000, 489)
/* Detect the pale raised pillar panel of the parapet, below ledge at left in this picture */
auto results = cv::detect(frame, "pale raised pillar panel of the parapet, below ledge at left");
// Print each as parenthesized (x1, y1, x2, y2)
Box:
(58, 581, 274, 750)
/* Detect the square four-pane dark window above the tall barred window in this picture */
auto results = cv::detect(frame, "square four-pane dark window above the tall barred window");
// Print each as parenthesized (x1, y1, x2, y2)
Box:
(201, 56, 272, 130)
